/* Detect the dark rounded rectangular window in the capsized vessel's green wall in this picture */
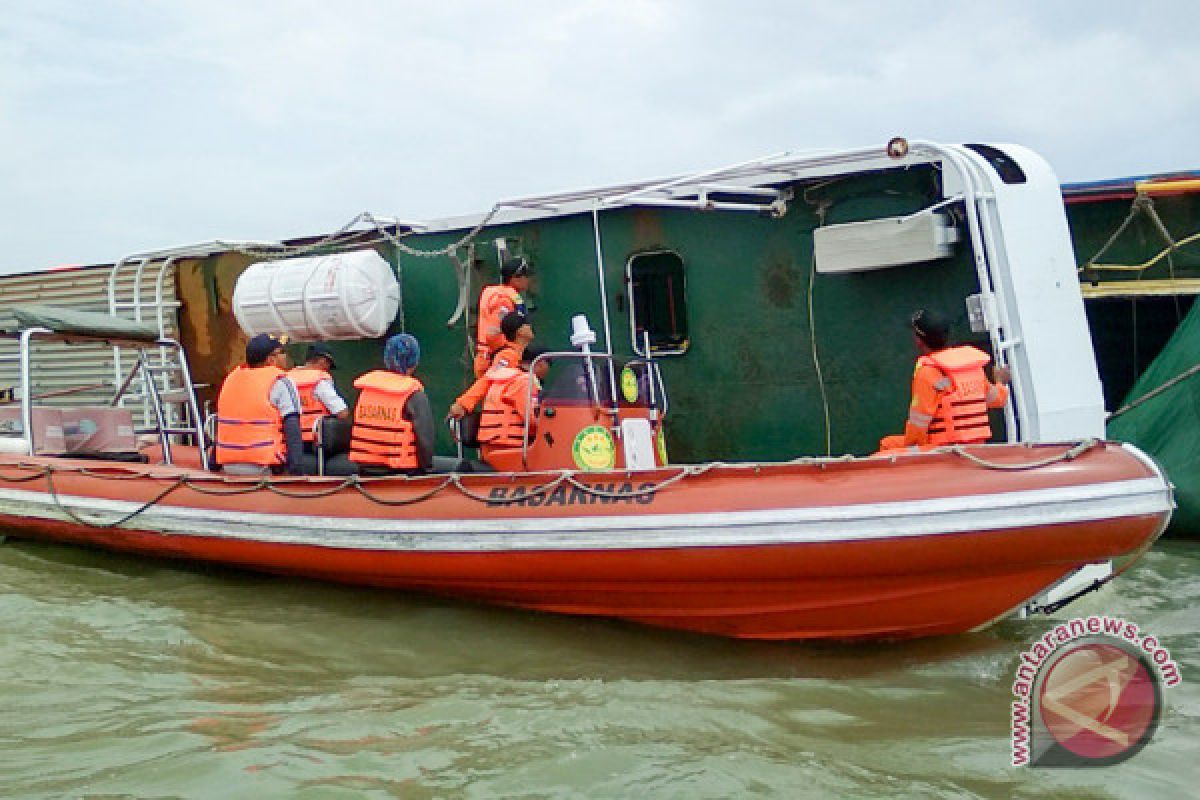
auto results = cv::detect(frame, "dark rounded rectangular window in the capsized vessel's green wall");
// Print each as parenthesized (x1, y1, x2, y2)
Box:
(625, 251, 689, 356)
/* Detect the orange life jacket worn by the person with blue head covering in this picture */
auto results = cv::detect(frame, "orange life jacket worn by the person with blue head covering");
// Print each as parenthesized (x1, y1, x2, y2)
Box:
(350, 369, 425, 469)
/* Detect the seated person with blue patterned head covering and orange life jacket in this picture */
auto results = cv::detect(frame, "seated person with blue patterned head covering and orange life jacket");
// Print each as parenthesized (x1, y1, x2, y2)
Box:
(350, 333, 434, 475)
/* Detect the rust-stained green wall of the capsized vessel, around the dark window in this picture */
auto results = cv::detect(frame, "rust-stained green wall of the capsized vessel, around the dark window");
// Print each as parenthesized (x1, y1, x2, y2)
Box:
(178, 166, 984, 462)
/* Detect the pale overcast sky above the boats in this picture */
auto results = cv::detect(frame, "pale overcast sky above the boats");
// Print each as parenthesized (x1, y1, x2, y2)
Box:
(0, 0, 1200, 272)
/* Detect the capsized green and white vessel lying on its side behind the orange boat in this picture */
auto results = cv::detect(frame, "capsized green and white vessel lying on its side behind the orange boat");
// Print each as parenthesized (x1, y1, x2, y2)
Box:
(4, 138, 1104, 474)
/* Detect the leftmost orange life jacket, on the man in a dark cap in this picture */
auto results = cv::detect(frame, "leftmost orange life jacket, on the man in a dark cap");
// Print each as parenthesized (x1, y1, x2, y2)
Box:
(216, 365, 287, 467)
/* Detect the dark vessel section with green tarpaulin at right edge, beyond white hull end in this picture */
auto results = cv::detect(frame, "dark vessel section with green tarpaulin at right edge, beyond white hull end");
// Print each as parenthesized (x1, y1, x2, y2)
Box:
(1063, 172, 1200, 537)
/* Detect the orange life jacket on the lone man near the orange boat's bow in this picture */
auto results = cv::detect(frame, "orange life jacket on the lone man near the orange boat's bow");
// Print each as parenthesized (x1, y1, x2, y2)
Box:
(917, 345, 991, 445)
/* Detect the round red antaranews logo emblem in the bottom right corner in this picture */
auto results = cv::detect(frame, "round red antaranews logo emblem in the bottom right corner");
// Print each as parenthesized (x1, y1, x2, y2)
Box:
(1037, 642, 1163, 765)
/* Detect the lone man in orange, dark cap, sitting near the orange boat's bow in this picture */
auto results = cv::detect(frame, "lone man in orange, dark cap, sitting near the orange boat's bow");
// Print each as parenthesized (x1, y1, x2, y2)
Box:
(880, 309, 1009, 451)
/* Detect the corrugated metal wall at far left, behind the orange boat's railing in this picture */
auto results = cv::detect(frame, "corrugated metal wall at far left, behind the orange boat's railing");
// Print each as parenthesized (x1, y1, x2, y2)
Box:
(0, 265, 179, 419)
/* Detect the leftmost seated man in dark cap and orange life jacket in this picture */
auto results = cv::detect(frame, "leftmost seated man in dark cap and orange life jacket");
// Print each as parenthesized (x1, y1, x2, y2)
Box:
(215, 333, 304, 475)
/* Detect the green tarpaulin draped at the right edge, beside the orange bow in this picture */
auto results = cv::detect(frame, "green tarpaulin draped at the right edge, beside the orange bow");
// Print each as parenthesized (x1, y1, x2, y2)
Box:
(1108, 297, 1200, 537)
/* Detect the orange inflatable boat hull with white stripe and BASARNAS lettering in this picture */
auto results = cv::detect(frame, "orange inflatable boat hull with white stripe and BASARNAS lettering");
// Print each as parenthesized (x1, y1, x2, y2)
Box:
(0, 443, 1172, 639)
